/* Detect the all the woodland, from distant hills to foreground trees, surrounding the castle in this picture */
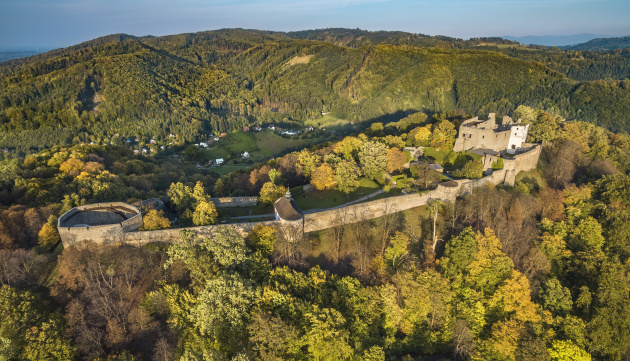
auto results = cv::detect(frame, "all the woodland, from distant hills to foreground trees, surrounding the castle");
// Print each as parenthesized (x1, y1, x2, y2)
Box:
(0, 29, 630, 361)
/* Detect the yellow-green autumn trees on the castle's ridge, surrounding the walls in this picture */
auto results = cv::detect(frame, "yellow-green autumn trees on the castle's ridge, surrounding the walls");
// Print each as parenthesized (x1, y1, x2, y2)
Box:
(0, 107, 630, 361)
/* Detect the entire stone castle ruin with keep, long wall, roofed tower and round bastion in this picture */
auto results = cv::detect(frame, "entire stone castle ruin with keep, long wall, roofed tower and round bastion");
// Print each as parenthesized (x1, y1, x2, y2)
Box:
(58, 113, 542, 246)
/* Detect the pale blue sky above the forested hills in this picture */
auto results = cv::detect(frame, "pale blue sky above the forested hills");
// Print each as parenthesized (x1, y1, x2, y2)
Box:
(0, 0, 630, 48)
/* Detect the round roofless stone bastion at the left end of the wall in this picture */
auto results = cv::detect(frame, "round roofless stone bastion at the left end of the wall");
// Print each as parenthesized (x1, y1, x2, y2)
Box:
(57, 202, 142, 247)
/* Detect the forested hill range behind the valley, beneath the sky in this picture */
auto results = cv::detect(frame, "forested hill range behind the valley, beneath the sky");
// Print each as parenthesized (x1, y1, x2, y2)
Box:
(0, 29, 630, 150)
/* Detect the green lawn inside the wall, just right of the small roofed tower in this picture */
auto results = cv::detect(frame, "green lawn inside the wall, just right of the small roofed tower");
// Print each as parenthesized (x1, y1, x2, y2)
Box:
(291, 178, 380, 211)
